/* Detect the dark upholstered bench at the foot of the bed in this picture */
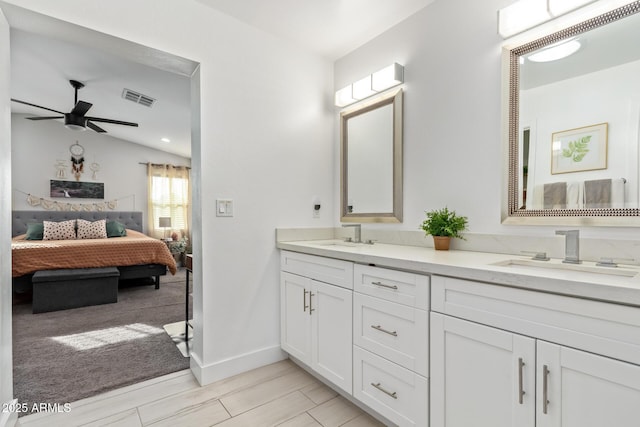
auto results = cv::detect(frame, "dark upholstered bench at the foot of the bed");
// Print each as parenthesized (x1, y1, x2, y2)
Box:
(32, 267, 120, 313)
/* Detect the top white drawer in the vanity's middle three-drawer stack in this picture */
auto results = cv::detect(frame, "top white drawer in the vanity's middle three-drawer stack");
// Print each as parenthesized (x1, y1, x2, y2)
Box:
(353, 264, 429, 310)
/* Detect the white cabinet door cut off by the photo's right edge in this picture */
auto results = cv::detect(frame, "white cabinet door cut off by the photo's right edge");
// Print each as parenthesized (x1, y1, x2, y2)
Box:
(536, 341, 640, 427)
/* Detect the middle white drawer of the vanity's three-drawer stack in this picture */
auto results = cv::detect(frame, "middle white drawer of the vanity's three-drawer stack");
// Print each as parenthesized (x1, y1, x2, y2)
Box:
(353, 292, 429, 377)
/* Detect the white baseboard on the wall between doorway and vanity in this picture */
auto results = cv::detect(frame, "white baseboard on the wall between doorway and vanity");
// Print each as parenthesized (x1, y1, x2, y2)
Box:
(191, 345, 288, 385)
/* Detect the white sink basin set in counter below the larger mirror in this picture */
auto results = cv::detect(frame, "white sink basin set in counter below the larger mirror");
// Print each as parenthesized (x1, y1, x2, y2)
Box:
(491, 259, 640, 279)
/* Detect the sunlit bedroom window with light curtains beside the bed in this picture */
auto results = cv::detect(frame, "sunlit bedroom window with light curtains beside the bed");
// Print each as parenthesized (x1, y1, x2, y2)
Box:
(148, 163, 191, 239)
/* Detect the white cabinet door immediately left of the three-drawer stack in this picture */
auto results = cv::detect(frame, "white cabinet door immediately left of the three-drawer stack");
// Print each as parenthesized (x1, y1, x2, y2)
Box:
(309, 281, 353, 393)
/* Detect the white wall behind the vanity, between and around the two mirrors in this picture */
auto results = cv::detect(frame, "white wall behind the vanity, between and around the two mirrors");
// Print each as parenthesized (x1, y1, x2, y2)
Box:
(334, 0, 640, 241)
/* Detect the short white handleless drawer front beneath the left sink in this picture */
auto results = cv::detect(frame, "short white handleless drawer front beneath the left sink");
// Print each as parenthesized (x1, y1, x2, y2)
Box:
(280, 251, 353, 289)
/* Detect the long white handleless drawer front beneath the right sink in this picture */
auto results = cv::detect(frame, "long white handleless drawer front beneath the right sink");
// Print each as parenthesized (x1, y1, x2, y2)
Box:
(431, 276, 640, 364)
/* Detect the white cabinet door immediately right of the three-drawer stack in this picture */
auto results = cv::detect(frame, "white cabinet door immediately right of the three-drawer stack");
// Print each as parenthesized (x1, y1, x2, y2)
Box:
(430, 313, 536, 427)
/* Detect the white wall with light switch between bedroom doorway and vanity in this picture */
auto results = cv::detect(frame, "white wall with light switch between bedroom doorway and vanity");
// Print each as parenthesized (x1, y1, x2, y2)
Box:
(2, 0, 337, 388)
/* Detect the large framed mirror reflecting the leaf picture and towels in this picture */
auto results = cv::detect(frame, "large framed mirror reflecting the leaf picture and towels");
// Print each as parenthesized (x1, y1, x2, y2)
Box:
(503, 1, 640, 226)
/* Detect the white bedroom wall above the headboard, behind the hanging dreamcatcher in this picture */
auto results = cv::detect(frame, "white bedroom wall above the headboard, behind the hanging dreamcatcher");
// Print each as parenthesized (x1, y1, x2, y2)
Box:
(11, 114, 191, 231)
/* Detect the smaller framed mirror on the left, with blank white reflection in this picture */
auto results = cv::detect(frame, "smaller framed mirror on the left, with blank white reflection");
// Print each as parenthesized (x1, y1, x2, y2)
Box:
(340, 89, 402, 222)
